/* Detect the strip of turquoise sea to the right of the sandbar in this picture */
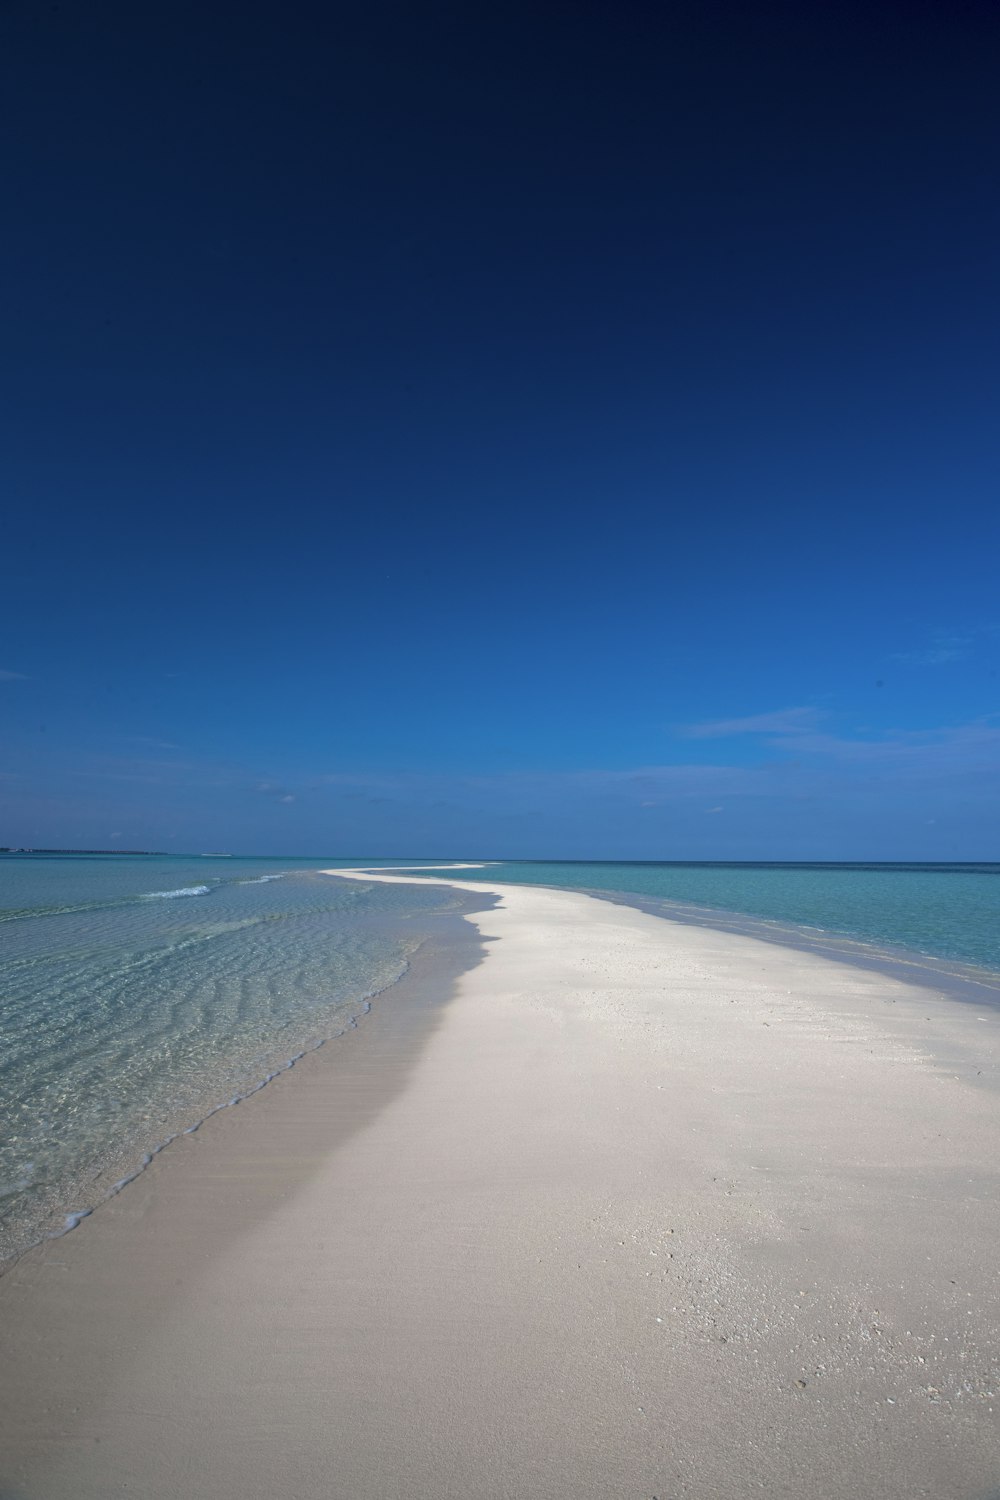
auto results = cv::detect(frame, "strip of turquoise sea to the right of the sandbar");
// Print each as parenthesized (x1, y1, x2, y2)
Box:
(401, 860, 1000, 986)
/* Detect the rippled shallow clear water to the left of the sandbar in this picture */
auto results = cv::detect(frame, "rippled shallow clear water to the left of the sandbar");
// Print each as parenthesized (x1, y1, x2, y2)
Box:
(0, 855, 465, 1265)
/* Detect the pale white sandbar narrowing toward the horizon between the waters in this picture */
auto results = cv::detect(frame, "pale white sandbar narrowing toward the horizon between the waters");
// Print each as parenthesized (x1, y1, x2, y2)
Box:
(0, 872, 1000, 1500)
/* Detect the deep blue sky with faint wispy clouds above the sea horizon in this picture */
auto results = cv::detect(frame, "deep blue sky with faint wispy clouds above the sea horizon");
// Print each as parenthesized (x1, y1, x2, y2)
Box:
(0, 0, 1000, 858)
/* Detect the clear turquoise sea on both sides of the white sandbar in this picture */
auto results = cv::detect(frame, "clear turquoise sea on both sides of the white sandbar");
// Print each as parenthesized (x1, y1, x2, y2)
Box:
(0, 854, 1000, 1260)
